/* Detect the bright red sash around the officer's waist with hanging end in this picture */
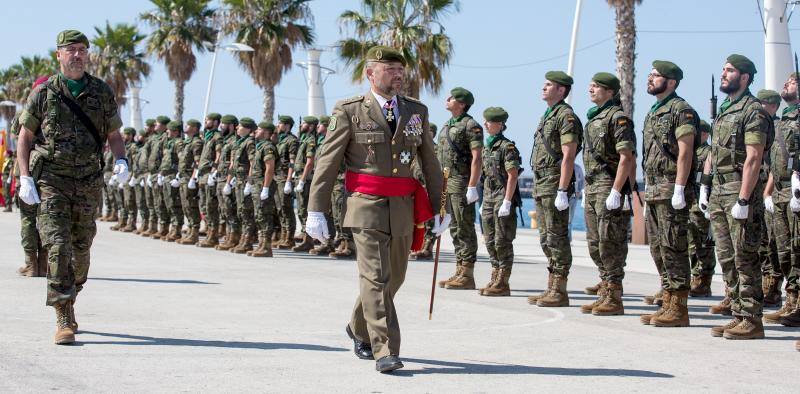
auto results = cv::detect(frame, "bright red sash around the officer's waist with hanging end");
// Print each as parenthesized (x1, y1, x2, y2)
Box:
(344, 171, 433, 251)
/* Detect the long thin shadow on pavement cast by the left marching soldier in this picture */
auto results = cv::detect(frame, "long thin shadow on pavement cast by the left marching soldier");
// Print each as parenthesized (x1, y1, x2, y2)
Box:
(79, 331, 347, 352)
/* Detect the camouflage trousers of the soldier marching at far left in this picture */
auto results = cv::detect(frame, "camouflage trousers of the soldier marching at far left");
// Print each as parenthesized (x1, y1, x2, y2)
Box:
(37, 171, 103, 305)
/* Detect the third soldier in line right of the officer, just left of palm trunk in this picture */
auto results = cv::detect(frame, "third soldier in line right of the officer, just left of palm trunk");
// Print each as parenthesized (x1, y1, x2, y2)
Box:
(528, 71, 583, 307)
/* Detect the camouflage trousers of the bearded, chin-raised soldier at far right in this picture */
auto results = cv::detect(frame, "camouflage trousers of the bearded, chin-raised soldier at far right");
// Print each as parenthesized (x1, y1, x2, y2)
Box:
(709, 190, 764, 318)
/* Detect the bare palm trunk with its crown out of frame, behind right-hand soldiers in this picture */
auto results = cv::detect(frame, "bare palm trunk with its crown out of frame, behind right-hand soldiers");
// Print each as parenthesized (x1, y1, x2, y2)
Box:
(606, 0, 642, 117)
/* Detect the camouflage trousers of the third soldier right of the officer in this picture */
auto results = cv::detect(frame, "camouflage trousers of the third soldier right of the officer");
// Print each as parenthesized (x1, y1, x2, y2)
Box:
(535, 195, 572, 276)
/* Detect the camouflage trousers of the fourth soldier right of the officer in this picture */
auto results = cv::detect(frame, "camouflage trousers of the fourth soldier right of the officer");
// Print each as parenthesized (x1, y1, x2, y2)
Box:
(584, 189, 631, 284)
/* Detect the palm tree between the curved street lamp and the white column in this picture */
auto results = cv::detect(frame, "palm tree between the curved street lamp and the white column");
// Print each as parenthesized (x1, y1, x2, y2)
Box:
(222, 0, 314, 120)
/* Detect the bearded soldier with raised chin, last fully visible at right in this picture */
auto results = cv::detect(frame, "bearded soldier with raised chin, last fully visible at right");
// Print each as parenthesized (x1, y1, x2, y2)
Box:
(699, 54, 774, 339)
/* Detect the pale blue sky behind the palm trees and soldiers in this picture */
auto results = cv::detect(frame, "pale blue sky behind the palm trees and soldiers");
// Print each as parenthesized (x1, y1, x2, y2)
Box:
(0, 0, 800, 167)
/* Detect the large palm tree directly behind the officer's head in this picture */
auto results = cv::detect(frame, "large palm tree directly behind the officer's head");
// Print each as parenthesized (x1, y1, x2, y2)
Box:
(338, 0, 459, 97)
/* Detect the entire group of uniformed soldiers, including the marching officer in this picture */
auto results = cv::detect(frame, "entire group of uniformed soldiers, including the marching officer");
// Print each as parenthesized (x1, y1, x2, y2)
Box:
(3, 31, 800, 372)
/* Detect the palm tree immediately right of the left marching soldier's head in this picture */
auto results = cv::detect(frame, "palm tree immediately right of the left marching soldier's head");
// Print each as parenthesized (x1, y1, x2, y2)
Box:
(90, 21, 150, 106)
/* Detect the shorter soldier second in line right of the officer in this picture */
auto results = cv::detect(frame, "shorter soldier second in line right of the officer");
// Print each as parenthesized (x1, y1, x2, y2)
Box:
(478, 107, 522, 297)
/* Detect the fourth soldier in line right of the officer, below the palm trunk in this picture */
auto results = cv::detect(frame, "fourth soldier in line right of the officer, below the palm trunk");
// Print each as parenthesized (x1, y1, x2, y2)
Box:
(581, 72, 636, 316)
